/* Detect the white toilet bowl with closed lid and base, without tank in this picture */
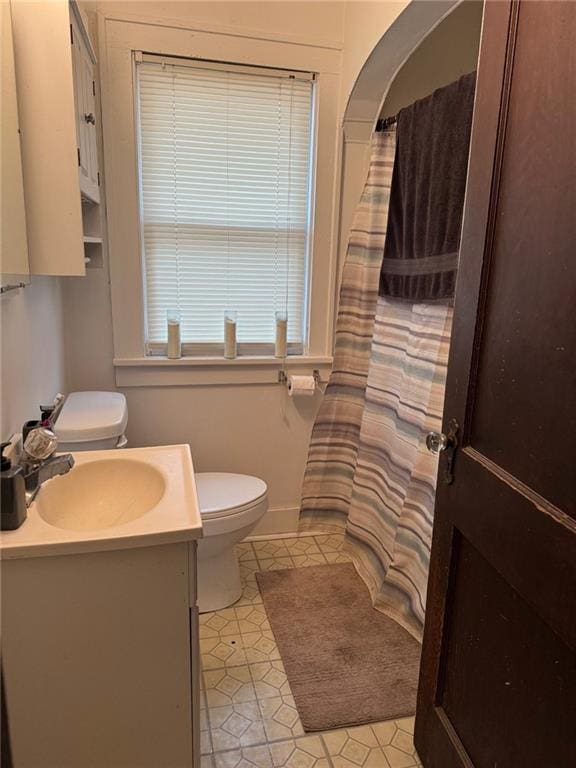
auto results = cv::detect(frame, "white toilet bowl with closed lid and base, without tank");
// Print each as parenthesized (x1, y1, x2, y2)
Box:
(196, 472, 268, 613)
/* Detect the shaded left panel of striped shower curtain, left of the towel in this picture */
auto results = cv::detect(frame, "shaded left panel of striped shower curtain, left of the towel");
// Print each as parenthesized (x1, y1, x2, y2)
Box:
(300, 128, 396, 532)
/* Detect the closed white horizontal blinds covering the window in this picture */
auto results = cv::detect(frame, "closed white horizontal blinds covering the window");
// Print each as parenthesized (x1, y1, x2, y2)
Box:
(137, 55, 313, 354)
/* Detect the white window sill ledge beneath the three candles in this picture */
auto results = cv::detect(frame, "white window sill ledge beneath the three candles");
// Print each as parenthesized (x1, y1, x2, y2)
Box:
(113, 355, 332, 387)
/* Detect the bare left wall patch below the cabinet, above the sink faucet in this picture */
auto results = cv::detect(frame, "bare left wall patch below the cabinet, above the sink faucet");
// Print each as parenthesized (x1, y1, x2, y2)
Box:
(0, 277, 66, 440)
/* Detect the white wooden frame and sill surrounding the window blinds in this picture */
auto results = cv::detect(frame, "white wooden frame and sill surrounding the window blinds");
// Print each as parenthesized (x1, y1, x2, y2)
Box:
(99, 18, 340, 386)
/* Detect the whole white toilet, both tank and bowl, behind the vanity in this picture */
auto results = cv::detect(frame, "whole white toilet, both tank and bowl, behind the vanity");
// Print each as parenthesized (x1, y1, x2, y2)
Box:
(54, 392, 268, 613)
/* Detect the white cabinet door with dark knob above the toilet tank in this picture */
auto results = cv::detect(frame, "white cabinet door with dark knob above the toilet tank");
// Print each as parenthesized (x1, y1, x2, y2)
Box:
(72, 16, 100, 203)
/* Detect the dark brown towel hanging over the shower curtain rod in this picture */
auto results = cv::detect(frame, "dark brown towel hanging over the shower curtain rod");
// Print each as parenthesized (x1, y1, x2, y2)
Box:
(380, 72, 476, 302)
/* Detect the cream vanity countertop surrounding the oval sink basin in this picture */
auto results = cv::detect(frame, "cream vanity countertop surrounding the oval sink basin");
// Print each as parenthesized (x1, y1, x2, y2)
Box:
(0, 445, 202, 559)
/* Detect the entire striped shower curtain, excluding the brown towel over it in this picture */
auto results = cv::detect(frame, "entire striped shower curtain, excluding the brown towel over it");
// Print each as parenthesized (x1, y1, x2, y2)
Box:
(300, 131, 452, 639)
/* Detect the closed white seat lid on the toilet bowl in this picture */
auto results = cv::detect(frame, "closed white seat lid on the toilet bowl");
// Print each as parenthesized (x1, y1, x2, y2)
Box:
(195, 472, 268, 518)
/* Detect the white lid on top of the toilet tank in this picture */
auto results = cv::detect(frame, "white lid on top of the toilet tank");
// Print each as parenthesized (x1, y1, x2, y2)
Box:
(54, 392, 128, 443)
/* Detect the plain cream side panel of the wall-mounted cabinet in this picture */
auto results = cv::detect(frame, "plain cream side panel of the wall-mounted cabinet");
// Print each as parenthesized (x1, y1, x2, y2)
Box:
(10, 0, 86, 276)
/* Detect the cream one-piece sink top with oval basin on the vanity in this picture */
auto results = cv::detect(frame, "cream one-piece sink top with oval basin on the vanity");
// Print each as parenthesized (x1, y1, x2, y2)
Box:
(0, 445, 202, 558)
